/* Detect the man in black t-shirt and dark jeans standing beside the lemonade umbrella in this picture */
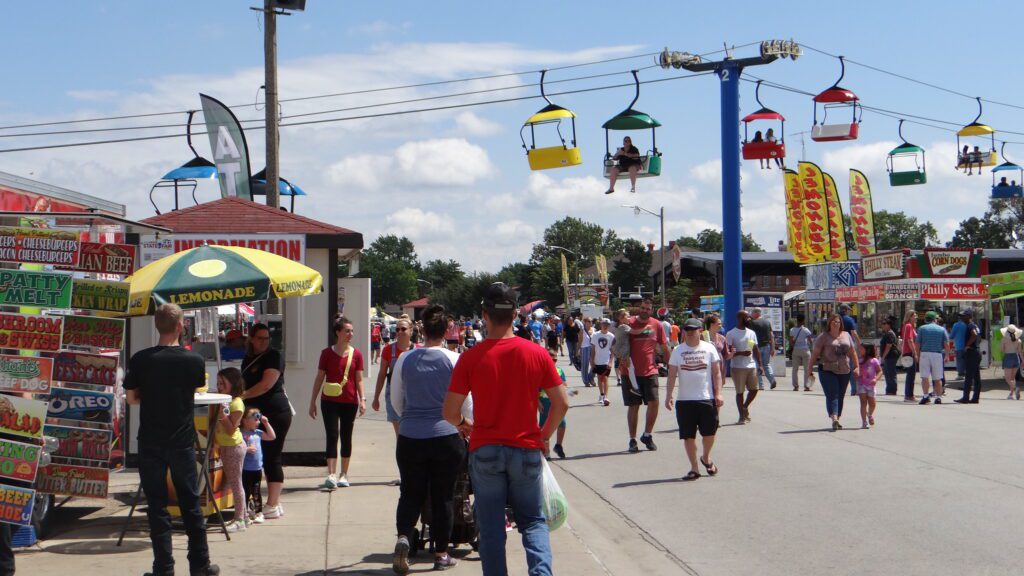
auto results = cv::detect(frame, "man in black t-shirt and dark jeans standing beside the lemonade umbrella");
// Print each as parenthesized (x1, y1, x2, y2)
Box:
(124, 304, 220, 576)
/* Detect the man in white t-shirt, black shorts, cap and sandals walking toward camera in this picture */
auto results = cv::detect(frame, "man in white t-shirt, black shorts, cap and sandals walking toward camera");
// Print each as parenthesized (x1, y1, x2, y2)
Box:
(665, 318, 724, 481)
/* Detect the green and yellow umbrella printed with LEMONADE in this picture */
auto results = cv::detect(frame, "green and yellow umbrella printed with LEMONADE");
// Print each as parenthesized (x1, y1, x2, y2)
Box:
(128, 240, 324, 316)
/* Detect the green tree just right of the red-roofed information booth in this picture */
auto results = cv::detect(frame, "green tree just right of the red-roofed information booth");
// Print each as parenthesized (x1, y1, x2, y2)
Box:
(358, 235, 420, 306)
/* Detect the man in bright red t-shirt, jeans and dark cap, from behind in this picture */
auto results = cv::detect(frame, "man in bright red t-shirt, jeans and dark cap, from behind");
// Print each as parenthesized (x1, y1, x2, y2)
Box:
(443, 282, 568, 575)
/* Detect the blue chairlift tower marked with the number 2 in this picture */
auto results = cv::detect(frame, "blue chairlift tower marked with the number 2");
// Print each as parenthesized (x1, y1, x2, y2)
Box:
(660, 40, 803, 328)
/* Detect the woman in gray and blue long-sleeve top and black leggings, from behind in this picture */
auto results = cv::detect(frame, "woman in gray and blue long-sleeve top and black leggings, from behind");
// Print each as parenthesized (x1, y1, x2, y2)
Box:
(391, 305, 473, 574)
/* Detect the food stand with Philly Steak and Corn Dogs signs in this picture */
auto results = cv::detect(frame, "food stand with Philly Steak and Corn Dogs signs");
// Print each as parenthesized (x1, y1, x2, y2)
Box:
(835, 248, 991, 368)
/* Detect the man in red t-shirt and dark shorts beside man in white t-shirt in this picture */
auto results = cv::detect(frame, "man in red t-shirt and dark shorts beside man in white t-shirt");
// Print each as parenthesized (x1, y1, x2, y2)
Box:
(622, 298, 669, 453)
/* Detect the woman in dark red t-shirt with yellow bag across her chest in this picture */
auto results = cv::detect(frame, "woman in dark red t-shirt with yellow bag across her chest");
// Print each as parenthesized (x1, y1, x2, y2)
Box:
(309, 317, 367, 490)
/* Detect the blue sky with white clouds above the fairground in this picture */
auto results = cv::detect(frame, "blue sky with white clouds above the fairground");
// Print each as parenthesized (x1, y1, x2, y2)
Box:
(0, 0, 1024, 270)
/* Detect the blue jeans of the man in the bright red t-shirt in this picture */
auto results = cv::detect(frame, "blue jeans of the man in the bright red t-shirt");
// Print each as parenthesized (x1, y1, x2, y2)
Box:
(469, 445, 552, 576)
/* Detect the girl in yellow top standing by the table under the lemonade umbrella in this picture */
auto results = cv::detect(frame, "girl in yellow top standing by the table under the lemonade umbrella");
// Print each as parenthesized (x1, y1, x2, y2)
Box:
(214, 368, 246, 532)
